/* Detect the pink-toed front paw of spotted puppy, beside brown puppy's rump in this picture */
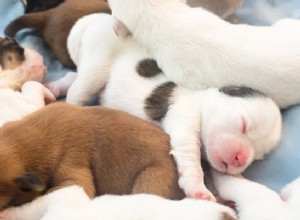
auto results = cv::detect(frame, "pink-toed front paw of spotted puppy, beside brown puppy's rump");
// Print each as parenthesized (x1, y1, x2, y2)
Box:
(179, 175, 216, 202)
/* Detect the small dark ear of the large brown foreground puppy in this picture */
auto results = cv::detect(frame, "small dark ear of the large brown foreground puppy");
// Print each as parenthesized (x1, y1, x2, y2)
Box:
(14, 173, 45, 192)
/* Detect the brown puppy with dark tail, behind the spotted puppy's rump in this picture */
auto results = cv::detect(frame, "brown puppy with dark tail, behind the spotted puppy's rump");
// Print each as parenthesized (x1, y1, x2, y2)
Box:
(5, 0, 110, 68)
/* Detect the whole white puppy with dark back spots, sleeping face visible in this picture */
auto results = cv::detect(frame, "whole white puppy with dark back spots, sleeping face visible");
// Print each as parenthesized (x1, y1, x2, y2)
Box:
(48, 14, 281, 200)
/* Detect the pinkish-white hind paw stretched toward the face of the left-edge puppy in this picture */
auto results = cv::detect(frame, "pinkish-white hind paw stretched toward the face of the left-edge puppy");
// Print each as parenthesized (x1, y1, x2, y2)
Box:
(45, 72, 77, 98)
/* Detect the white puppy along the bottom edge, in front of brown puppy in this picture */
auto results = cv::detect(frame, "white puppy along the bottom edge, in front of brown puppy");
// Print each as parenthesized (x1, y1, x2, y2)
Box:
(0, 186, 236, 220)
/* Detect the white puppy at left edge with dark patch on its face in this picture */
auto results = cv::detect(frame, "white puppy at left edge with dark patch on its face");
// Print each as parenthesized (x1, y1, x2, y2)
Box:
(0, 38, 55, 126)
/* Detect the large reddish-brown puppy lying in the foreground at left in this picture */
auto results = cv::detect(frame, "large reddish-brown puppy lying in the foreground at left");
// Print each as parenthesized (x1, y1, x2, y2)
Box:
(0, 103, 183, 209)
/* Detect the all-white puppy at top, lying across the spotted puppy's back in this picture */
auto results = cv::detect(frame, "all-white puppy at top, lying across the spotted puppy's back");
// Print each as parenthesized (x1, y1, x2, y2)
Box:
(108, 0, 300, 108)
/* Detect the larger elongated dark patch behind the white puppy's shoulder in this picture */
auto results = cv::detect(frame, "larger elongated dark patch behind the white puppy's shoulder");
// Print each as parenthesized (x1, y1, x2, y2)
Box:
(144, 82, 176, 121)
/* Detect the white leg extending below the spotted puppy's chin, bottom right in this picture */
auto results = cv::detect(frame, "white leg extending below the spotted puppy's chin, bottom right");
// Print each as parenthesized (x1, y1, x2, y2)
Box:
(212, 170, 287, 220)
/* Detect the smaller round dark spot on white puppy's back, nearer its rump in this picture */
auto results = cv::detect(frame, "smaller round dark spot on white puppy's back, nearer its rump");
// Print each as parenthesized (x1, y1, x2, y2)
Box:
(136, 59, 162, 78)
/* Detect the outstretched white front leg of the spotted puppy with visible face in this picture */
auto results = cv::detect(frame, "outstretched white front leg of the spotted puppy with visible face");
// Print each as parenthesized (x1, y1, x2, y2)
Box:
(162, 97, 215, 201)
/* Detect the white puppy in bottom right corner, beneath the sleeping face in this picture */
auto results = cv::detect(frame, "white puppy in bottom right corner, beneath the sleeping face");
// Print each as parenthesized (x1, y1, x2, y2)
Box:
(212, 171, 300, 220)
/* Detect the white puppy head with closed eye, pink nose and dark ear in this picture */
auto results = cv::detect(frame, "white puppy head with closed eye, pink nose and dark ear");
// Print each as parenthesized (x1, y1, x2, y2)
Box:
(201, 87, 282, 174)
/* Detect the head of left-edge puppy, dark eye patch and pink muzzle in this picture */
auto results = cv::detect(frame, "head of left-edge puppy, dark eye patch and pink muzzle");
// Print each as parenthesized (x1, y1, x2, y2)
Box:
(0, 37, 47, 90)
